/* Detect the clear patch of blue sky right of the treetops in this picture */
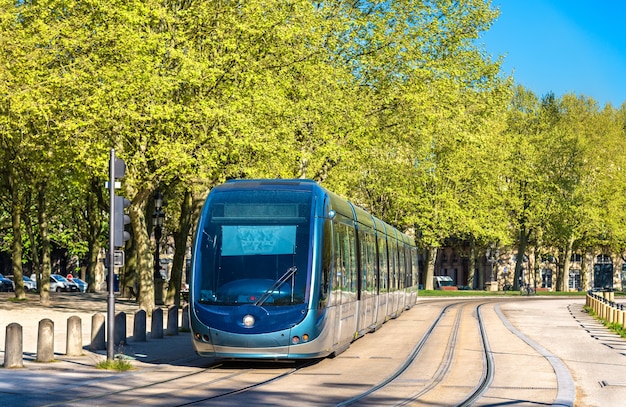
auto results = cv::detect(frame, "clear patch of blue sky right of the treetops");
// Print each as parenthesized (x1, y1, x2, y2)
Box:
(481, 0, 626, 108)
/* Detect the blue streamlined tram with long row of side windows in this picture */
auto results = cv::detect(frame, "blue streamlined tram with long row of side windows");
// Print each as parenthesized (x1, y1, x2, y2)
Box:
(189, 180, 418, 360)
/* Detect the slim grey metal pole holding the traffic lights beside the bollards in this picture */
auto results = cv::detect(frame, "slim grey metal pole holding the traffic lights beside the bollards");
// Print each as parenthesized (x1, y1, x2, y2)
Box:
(107, 148, 115, 360)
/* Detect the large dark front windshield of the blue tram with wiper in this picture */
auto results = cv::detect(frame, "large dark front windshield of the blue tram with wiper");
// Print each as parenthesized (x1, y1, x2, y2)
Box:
(194, 190, 312, 306)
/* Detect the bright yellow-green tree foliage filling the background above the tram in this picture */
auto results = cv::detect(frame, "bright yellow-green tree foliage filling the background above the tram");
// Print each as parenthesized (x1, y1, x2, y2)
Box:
(0, 0, 626, 300)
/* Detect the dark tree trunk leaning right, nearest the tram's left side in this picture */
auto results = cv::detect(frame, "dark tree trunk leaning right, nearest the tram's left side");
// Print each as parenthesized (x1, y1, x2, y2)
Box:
(165, 190, 192, 306)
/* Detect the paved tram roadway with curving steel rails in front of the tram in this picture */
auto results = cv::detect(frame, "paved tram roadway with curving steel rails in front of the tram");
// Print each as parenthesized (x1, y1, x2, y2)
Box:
(22, 299, 575, 406)
